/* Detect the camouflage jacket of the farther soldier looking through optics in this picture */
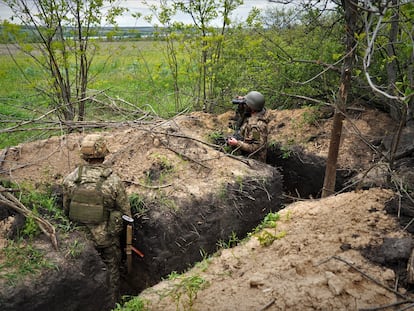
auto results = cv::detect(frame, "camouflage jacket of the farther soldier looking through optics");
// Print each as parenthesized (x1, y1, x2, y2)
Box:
(237, 109, 268, 162)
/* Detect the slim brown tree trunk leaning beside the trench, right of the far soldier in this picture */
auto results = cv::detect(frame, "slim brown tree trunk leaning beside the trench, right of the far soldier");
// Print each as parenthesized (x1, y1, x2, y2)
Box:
(322, 0, 358, 198)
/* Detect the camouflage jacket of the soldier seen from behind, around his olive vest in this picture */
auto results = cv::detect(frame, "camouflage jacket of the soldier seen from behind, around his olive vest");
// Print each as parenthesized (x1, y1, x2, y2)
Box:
(63, 165, 131, 247)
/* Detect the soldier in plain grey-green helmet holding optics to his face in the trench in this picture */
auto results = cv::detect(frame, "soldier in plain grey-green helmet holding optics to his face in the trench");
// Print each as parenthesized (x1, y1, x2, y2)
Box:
(227, 91, 268, 163)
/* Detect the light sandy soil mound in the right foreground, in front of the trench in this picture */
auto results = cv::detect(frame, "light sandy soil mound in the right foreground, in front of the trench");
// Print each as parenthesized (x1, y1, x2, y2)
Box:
(141, 189, 408, 311)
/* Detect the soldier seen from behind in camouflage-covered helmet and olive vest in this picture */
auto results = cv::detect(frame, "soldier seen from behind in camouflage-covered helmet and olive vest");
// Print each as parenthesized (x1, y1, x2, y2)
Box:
(63, 134, 131, 303)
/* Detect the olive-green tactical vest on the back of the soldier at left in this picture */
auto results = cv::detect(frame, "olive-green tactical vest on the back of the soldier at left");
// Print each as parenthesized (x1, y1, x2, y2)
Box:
(69, 167, 108, 224)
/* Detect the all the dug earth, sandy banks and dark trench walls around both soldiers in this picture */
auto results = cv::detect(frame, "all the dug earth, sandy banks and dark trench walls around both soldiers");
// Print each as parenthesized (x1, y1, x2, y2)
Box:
(0, 108, 414, 310)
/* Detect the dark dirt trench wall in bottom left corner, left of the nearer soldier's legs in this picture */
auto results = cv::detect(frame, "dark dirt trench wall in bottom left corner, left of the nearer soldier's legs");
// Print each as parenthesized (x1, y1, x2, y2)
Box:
(0, 234, 113, 311)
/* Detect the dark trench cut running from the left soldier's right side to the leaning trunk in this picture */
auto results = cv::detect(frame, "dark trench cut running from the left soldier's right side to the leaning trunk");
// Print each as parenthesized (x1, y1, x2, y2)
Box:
(118, 147, 352, 295)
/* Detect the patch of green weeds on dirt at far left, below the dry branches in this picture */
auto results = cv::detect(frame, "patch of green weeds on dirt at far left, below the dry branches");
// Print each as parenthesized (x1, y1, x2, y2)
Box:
(0, 240, 56, 285)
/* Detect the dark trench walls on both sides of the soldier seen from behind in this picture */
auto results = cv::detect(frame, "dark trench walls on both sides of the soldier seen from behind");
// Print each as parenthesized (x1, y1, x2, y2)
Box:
(0, 148, 352, 311)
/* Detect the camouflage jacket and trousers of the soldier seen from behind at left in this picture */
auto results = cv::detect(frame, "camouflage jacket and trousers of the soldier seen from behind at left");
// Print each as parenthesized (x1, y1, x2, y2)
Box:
(63, 164, 131, 302)
